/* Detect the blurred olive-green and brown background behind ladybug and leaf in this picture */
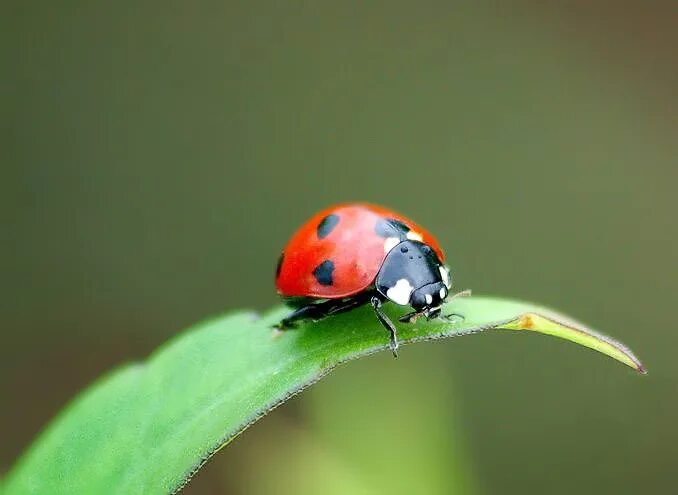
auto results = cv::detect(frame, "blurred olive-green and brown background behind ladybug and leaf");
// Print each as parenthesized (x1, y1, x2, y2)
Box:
(0, 0, 678, 494)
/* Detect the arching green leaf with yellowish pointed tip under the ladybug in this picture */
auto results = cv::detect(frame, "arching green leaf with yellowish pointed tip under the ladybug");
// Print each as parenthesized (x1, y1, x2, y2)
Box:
(4, 297, 644, 494)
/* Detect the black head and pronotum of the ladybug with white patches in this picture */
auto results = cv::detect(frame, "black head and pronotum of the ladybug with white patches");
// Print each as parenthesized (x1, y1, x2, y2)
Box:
(375, 240, 451, 311)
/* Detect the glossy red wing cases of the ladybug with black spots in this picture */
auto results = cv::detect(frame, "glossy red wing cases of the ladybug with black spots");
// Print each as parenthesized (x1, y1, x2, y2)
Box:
(275, 203, 444, 299)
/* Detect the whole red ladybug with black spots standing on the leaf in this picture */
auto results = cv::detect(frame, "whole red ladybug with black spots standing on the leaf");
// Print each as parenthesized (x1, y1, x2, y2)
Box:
(275, 203, 468, 356)
